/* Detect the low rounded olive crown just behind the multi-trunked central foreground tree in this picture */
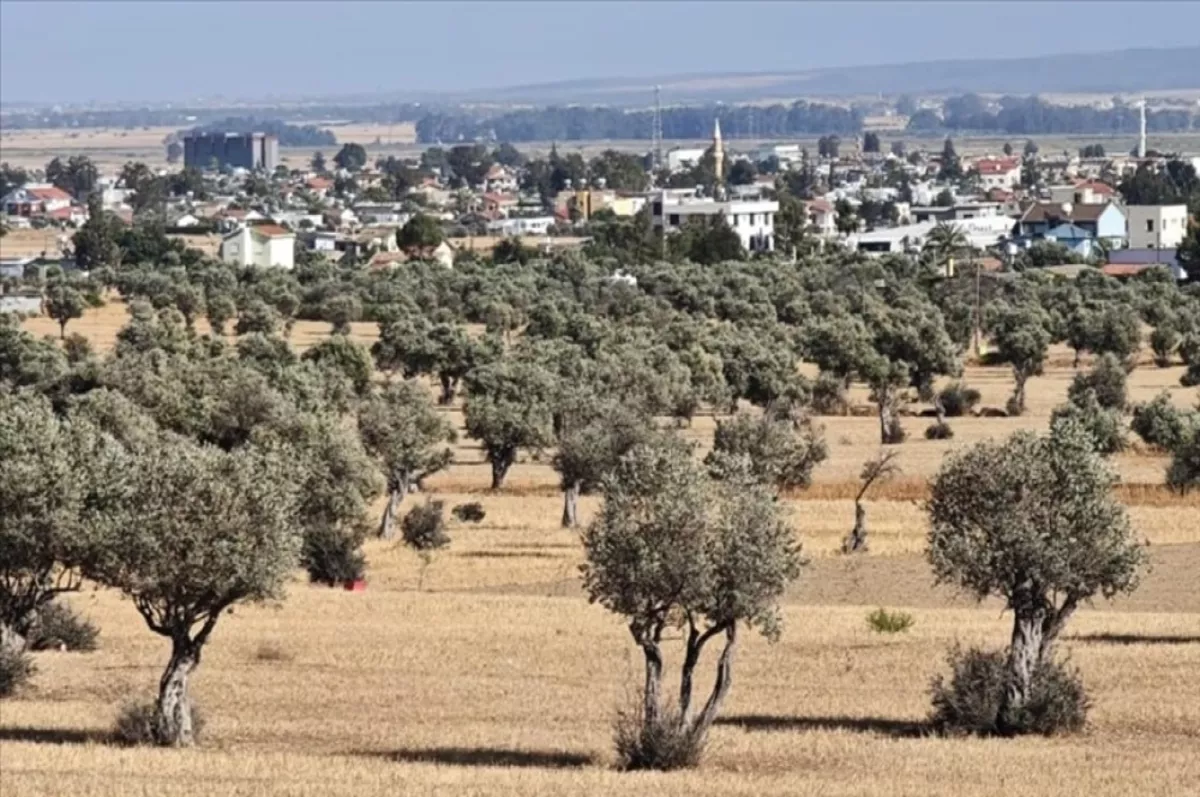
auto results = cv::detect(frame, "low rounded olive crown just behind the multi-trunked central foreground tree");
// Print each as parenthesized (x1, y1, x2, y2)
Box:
(704, 412, 829, 490)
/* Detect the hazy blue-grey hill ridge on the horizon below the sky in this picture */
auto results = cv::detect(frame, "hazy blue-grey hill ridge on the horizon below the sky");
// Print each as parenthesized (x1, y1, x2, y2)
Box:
(434, 46, 1200, 106)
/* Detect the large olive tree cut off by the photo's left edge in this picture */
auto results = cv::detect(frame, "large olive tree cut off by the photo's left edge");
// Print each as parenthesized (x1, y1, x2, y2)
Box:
(0, 392, 114, 651)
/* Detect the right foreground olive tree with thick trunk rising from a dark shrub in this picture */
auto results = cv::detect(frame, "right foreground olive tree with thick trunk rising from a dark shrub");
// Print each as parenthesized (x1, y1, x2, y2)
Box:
(926, 423, 1145, 725)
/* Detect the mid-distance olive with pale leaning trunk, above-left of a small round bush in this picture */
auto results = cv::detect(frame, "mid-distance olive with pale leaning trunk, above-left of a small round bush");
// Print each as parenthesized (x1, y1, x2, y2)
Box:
(359, 382, 455, 539)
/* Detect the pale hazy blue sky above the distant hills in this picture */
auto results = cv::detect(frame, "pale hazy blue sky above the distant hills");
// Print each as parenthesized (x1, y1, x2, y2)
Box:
(0, 0, 1200, 104)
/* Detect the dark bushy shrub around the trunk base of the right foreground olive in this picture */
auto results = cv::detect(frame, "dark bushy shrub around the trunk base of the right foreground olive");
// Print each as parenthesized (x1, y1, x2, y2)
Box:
(930, 647, 1091, 736)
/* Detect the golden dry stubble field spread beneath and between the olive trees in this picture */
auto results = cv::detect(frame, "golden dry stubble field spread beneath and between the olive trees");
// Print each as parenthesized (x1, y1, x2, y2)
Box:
(0, 295, 1200, 797)
